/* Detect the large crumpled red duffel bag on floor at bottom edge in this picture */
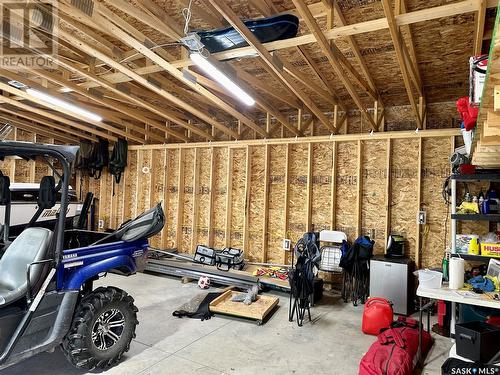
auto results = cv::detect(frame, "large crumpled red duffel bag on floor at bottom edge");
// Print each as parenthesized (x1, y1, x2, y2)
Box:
(359, 318, 432, 375)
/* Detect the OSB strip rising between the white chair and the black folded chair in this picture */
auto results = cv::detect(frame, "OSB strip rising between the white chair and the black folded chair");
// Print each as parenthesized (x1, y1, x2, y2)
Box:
(335, 142, 358, 241)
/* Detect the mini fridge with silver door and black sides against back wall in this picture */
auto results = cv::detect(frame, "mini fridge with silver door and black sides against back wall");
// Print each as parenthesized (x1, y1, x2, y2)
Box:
(370, 255, 415, 315)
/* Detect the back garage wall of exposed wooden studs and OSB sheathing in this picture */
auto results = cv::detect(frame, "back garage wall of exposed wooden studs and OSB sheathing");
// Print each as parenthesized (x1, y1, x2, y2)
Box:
(85, 130, 455, 267)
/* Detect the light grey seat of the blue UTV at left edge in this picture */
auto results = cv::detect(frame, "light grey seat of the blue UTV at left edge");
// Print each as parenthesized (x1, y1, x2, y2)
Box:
(0, 228, 52, 306)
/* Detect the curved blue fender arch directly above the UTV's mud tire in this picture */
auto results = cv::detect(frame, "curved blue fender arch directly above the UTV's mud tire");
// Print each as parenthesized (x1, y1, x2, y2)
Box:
(64, 255, 137, 290)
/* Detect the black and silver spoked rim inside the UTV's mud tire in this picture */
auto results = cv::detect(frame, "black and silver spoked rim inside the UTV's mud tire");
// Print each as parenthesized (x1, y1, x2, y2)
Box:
(92, 309, 125, 350)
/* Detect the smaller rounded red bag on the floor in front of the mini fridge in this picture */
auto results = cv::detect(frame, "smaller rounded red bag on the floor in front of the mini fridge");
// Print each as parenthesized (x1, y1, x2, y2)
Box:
(361, 297, 394, 335)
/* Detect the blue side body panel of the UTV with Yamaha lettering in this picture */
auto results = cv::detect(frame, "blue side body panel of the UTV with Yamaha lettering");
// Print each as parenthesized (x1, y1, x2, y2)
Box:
(57, 238, 148, 291)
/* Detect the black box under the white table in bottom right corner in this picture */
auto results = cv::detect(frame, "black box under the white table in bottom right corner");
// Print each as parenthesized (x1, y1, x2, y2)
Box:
(455, 321, 500, 363)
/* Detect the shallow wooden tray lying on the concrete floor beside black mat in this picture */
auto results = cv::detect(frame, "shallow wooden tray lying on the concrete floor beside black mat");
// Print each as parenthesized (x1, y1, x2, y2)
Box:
(210, 290, 279, 321)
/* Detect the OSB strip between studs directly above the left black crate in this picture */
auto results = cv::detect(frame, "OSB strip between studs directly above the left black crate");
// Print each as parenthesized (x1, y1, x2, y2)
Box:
(197, 148, 212, 245)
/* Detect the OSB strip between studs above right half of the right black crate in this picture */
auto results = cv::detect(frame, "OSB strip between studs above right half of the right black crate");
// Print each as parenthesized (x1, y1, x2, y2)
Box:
(230, 148, 246, 248)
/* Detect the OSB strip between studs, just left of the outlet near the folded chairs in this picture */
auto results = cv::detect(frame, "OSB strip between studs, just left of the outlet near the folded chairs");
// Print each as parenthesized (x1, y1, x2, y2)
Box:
(267, 145, 288, 264)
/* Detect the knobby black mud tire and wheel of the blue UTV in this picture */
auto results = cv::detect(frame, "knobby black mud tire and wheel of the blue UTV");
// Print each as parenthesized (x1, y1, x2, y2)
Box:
(61, 287, 139, 370)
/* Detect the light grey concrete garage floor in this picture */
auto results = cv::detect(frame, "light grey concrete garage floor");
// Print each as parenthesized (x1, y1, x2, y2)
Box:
(1, 274, 451, 375)
